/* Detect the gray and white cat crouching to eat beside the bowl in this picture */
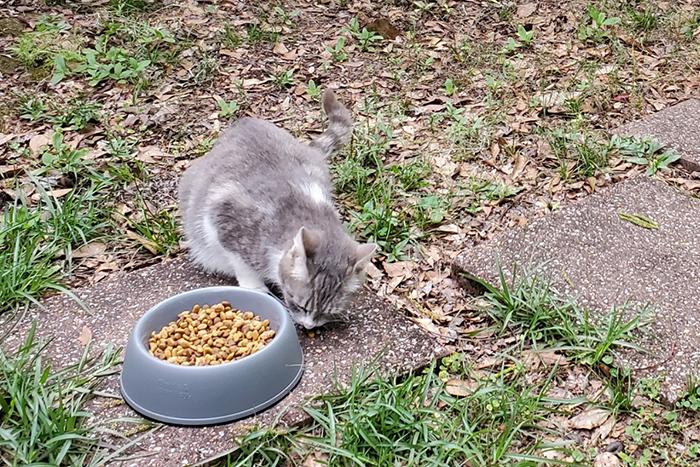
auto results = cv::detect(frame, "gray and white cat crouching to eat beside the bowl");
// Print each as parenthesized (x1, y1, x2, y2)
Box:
(179, 91, 376, 329)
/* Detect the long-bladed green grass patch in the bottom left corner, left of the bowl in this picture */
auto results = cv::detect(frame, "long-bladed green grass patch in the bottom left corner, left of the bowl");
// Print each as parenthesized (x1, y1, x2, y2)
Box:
(0, 325, 120, 466)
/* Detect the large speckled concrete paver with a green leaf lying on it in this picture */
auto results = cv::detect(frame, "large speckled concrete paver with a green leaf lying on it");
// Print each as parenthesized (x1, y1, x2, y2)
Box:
(453, 177, 700, 400)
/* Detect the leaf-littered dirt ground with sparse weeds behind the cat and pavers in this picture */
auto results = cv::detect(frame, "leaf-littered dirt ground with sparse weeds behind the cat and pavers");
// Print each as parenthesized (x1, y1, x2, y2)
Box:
(0, 0, 700, 465)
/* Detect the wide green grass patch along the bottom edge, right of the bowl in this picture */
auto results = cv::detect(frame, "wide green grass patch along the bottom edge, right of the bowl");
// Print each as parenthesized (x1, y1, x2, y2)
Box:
(226, 366, 580, 467)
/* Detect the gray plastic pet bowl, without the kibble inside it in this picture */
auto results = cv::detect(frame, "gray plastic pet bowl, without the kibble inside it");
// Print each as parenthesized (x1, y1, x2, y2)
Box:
(120, 287, 304, 425)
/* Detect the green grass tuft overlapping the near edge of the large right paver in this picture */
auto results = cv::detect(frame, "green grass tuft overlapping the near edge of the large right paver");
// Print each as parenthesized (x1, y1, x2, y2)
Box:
(470, 267, 650, 365)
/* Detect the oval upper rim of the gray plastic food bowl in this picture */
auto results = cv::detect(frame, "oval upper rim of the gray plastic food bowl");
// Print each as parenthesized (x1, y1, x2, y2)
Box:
(131, 285, 296, 372)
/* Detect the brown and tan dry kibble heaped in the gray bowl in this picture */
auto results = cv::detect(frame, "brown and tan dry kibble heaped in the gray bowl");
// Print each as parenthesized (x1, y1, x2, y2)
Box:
(148, 302, 275, 366)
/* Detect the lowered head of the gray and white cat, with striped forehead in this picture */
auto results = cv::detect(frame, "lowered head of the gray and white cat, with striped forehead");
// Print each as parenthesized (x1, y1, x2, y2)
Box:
(280, 227, 377, 329)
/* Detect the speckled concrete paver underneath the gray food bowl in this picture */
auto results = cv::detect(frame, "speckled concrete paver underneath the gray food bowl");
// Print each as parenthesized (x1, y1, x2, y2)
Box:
(0, 258, 447, 467)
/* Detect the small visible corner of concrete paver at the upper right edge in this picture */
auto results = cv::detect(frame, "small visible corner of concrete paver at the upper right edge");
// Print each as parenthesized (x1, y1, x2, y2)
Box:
(616, 99, 700, 172)
